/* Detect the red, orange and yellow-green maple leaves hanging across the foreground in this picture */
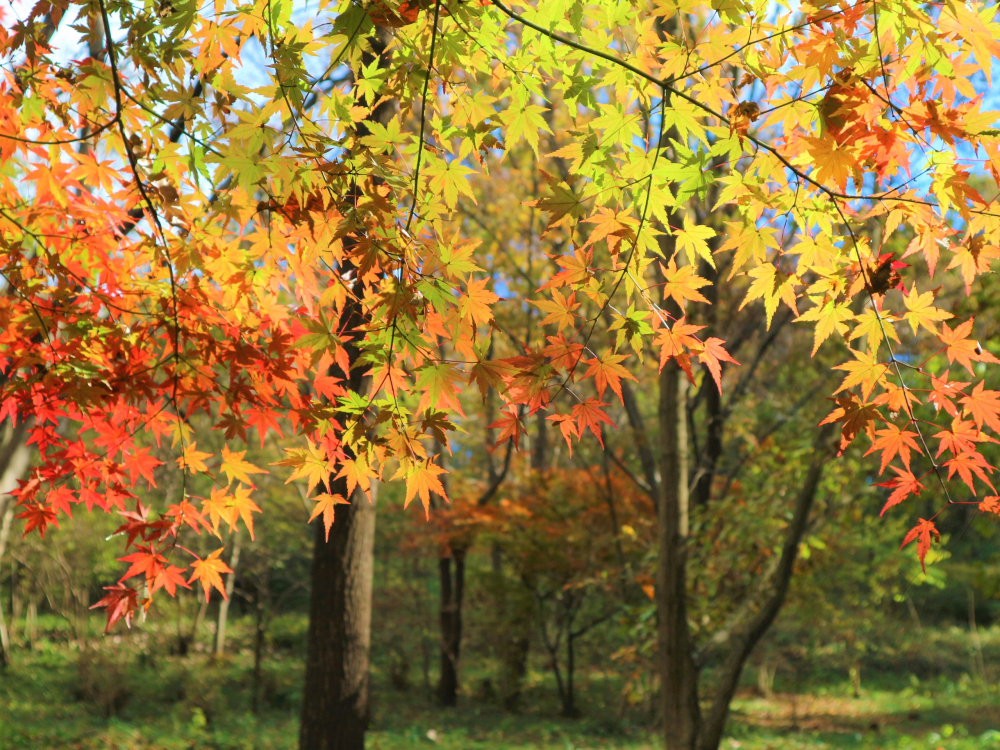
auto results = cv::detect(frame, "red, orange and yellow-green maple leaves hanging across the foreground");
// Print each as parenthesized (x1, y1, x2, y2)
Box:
(0, 0, 1000, 627)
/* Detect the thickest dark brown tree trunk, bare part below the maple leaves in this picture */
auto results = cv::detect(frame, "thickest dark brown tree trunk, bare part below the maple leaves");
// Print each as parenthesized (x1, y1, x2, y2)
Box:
(299, 478, 377, 750)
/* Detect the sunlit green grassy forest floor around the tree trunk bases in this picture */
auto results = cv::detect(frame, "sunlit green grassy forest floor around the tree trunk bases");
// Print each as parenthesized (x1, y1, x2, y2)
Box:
(0, 641, 1000, 750)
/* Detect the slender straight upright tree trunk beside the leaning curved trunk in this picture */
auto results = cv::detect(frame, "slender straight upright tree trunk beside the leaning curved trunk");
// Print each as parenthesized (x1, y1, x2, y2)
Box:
(656, 360, 701, 750)
